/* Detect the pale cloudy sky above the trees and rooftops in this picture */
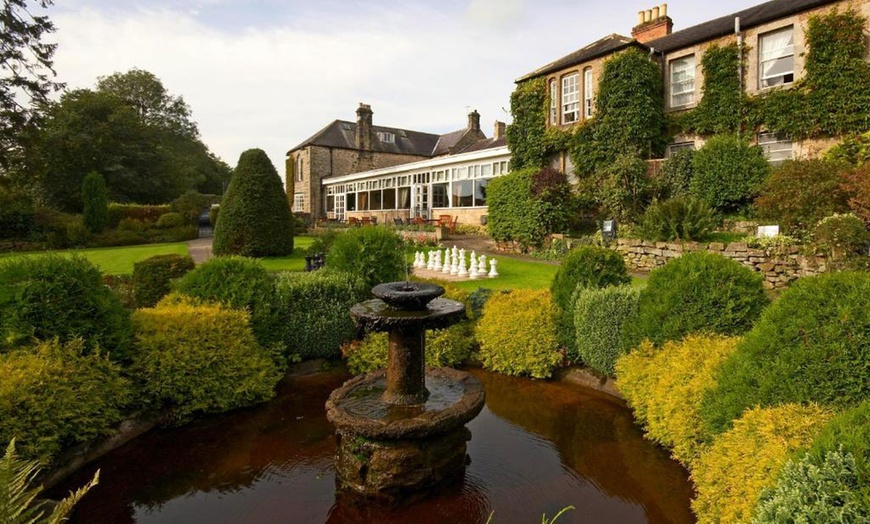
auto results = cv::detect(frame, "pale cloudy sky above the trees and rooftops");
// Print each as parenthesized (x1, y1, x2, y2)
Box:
(49, 0, 761, 182)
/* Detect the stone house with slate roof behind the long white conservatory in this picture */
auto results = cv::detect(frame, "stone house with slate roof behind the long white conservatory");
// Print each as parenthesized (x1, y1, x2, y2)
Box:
(285, 104, 486, 218)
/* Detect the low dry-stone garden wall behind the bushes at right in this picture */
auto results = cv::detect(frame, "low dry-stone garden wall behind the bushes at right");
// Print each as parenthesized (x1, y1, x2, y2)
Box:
(612, 238, 827, 289)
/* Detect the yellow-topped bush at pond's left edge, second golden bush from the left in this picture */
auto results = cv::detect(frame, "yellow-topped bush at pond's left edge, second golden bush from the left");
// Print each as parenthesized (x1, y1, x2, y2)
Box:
(131, 301, 281, 423)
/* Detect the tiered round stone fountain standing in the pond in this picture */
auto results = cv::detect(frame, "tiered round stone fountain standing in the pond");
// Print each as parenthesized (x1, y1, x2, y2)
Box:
(326, 282, 484, 502)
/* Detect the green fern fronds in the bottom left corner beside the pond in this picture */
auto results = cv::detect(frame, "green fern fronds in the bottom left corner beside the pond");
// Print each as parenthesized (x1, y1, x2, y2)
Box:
(0, 439, 100, 524)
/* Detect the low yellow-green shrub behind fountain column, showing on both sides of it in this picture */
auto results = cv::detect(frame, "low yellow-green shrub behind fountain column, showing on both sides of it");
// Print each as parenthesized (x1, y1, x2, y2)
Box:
(344, 322, 475, 375)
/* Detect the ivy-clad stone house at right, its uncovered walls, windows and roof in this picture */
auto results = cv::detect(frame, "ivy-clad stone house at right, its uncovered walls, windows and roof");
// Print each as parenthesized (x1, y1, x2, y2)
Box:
(517, 0, 870, 170)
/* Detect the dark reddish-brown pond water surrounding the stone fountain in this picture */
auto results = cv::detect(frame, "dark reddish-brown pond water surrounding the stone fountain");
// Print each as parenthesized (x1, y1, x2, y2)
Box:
(53, 370, 694, 524)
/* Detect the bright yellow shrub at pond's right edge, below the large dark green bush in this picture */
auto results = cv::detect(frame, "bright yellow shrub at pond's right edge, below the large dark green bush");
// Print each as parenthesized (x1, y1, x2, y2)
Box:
(616, 335, 739, 466)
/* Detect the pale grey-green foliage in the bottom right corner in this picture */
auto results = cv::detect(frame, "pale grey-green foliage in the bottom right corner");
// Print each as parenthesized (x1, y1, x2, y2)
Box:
(752, 451, 870, 524)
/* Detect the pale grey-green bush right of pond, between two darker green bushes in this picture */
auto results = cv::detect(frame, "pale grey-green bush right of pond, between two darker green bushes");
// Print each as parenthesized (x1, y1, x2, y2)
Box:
(568, 286, 640, 377)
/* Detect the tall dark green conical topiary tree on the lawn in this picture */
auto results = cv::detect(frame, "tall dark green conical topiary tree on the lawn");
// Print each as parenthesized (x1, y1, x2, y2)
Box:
(212, 149, 293, 257)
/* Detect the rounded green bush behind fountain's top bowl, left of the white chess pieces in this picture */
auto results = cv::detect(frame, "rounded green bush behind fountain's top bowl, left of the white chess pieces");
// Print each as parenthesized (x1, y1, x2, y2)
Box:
(326, 227, 407, 288)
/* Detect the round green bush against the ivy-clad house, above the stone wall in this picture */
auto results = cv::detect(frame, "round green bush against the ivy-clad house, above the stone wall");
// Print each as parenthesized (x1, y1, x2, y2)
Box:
(689, 135, 770, 213)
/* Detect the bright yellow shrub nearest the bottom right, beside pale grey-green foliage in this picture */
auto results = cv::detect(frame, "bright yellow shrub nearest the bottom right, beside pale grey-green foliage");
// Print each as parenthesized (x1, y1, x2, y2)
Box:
(692, 404, 832, 524)
